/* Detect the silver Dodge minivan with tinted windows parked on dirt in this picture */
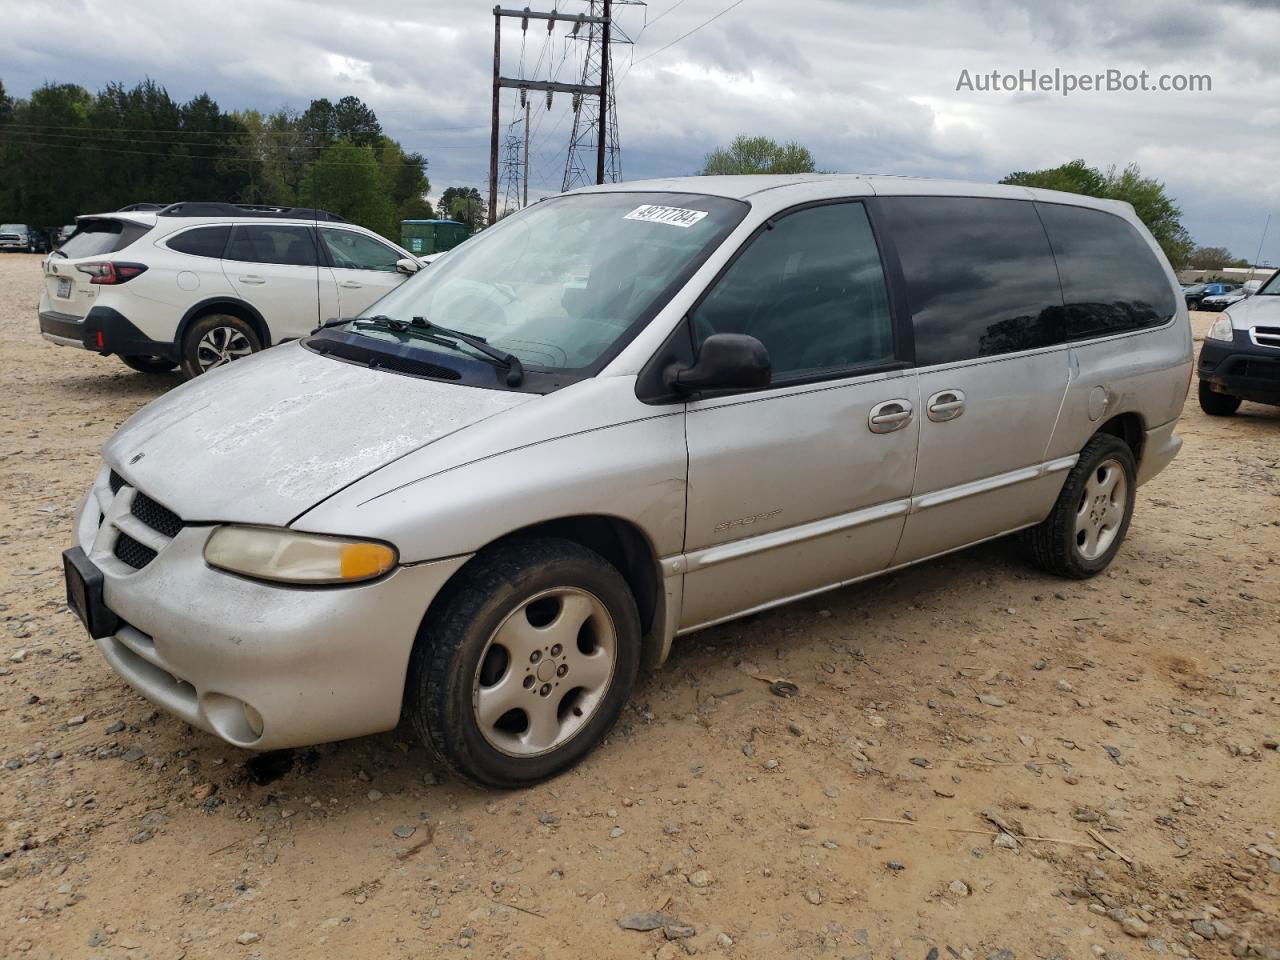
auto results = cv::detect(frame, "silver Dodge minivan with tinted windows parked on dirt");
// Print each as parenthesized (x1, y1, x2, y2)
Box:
(65, 175, 1192, 787)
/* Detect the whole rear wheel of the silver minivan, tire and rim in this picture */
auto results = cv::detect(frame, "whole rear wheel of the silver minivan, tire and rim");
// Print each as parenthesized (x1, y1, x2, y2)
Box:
(1025, 434, 1138, 580)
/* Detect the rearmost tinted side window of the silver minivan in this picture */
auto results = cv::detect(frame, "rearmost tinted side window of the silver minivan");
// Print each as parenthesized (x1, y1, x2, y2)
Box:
(1036, 204, 1175, 340)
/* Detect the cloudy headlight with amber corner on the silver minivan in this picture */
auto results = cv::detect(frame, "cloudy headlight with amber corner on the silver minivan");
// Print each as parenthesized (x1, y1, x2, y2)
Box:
(205, 526, 398, 584)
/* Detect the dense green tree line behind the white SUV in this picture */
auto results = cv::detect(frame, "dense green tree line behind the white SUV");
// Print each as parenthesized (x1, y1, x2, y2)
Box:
(0, 79, 472, 238)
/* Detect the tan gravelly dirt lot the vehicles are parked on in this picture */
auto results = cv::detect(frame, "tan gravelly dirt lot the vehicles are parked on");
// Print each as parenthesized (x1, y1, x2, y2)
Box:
(0, 255, 1280, 960)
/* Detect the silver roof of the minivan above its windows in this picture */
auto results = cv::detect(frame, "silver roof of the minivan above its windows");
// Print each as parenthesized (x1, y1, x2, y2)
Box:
(573, 173, 1130, 211)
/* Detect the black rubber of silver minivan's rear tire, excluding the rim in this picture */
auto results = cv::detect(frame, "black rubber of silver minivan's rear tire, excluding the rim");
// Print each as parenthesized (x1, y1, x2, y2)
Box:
(1023, 434, 1138, 580)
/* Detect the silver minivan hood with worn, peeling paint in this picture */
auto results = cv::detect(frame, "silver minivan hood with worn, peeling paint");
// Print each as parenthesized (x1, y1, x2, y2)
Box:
(102, 343, 536, 532)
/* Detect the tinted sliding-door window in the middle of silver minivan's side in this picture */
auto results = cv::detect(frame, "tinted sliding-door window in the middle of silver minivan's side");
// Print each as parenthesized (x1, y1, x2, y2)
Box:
(878, 197, 1062, 366)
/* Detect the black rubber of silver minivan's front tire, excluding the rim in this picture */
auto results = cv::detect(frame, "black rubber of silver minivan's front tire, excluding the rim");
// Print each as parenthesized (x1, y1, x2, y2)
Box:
(404, 538, 640, 788)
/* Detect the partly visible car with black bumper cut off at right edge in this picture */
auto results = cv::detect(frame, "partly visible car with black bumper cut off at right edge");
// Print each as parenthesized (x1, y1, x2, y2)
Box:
(1198, 273, 1280, 416)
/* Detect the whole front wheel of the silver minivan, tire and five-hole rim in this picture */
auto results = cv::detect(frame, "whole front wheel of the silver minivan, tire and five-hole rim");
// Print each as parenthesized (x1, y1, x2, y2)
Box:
(404, 538, 640, 787)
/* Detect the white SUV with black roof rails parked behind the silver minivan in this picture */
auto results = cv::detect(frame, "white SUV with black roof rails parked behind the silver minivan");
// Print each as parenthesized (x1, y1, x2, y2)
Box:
(40, 204, 422, 376)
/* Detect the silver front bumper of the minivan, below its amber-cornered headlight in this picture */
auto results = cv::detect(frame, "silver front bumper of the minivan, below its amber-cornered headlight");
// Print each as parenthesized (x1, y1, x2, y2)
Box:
(77, 470, 467, 750)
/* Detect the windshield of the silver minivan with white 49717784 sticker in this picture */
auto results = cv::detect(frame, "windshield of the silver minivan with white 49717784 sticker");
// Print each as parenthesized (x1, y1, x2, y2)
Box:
(348, 192, 748, 371)
